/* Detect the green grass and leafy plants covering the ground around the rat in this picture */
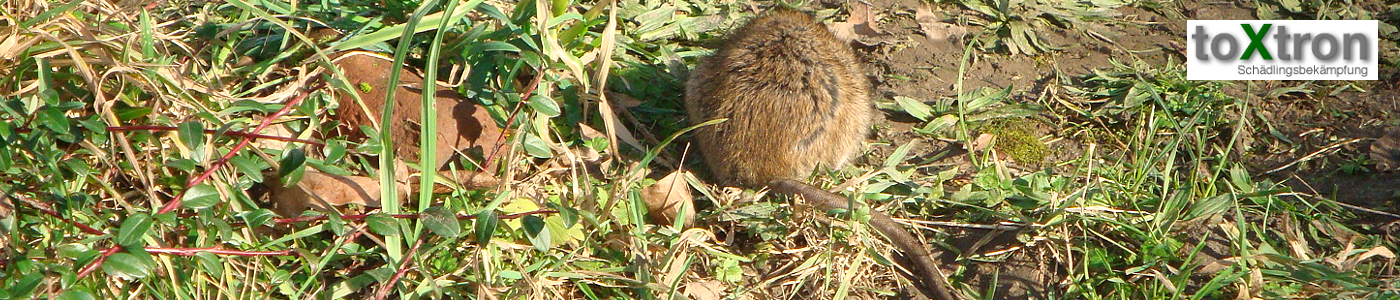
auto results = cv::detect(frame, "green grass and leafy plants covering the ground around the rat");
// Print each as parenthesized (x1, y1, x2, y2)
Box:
(0, 0, 1400, 299)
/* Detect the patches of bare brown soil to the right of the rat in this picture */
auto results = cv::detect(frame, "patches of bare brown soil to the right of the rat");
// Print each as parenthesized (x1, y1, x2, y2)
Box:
(840, 0, 1400, 299)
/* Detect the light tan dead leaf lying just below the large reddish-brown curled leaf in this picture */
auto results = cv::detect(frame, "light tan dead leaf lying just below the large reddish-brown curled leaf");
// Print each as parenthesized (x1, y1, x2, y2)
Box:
(267, 170, 409, 217)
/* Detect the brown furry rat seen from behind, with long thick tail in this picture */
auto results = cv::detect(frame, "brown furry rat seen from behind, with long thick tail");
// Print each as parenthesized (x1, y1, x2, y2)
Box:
(685, 8, 955, 300)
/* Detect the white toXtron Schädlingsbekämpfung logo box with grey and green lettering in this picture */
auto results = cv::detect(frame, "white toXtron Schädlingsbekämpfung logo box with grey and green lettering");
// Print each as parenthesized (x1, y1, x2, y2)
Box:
(1186, 20, 1380, 80)
